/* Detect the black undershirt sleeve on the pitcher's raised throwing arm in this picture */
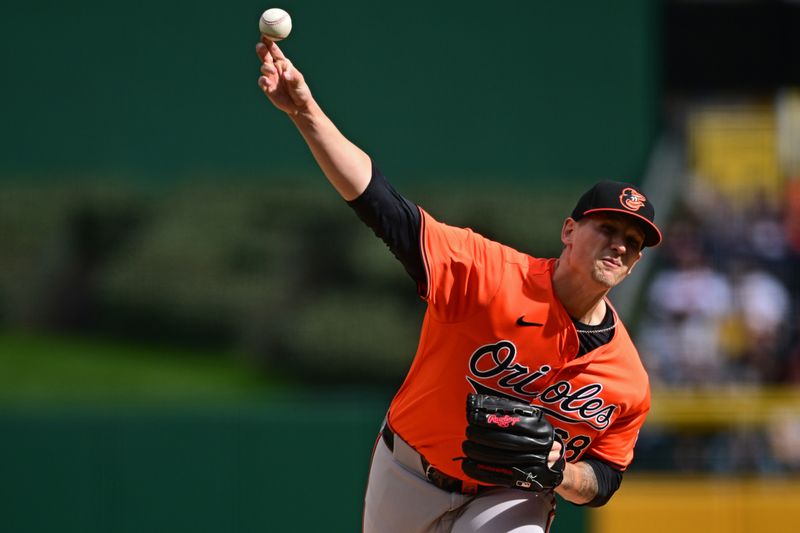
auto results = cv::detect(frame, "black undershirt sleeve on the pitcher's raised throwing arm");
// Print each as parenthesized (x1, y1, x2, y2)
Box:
(347, 162, 427, 286)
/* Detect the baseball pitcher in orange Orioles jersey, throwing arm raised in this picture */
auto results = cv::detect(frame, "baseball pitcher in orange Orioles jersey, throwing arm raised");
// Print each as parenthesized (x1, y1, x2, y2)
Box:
(256, 35, 661, 533)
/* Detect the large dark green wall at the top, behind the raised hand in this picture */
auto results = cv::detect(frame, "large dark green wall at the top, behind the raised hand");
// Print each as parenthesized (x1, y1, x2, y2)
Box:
(0, 0, 658, 183)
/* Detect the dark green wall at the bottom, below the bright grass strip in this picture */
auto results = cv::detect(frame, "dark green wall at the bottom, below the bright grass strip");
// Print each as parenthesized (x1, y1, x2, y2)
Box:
(0, 395, 584, 533)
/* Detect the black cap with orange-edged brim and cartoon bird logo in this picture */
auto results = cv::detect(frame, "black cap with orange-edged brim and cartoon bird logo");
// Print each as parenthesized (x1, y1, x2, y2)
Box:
(572, 181, 661, 246)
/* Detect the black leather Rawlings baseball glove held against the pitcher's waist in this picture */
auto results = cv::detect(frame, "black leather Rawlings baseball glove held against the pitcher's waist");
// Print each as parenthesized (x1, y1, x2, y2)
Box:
(461, 394, 566, 491)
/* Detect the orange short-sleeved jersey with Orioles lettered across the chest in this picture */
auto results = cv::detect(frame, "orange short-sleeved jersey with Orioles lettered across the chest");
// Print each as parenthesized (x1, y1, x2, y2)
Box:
(389, 210, 650, 481)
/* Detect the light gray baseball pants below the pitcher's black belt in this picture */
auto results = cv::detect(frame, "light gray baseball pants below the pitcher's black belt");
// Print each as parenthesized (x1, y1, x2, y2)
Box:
(363, 426, 555, 533)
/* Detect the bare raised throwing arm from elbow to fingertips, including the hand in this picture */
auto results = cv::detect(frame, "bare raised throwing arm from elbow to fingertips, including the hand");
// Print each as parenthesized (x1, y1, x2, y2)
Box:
(256, 38, 372, 201)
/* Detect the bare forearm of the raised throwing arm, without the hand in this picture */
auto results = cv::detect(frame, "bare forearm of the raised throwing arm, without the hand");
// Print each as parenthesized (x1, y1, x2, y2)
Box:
(290, 99, 372, 201)
